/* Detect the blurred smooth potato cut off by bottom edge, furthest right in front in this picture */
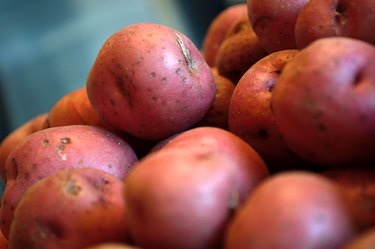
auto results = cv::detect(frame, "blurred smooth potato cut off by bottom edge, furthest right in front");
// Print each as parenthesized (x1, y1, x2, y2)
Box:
(224, 171, 354, 249)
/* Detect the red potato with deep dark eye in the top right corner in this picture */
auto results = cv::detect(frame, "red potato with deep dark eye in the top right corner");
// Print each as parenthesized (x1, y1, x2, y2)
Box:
(295, 0, 375, 49)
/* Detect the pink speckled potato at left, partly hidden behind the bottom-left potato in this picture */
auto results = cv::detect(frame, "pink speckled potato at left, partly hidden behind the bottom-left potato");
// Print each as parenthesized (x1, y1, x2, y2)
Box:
(0, 125, 138, 238)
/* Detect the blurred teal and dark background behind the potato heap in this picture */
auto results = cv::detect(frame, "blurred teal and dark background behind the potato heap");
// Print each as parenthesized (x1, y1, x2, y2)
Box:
(0, 0, 246, 140)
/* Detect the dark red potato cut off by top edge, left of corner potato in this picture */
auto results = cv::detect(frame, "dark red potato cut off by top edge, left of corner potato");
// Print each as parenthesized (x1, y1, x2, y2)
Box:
(247, 0, 310, 53)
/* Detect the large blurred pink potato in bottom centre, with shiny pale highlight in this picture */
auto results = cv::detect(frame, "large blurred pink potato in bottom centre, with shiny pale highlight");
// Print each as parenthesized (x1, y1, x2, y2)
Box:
(125, 127, 268, 249)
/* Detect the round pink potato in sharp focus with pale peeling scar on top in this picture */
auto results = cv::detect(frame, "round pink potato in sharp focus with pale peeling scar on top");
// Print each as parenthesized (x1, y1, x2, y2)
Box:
(86, 23, 215, 140)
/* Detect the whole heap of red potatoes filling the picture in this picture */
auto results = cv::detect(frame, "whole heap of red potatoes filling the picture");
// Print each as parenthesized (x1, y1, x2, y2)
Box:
(0, 0, 375, 249)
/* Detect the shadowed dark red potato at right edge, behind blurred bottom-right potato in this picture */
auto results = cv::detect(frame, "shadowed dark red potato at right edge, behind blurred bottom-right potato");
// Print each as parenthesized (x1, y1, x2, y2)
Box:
(322, 168, 375, 231)
